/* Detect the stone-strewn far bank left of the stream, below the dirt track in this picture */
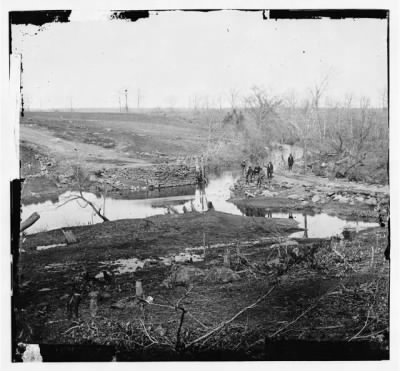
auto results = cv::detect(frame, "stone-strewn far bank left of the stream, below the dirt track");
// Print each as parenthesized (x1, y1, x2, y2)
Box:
(21, 142, 198, 204)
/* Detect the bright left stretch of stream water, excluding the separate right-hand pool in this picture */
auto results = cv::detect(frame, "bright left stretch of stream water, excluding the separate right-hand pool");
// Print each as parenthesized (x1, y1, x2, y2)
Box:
(21, 172, 241, 233)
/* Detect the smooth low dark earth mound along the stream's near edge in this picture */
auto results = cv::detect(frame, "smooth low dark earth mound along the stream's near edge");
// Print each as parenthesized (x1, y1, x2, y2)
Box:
(23, 210, 302, 254)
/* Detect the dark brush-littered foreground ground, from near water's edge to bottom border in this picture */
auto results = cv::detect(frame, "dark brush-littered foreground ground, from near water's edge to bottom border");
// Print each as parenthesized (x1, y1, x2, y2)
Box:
(17, 211, 389, 359)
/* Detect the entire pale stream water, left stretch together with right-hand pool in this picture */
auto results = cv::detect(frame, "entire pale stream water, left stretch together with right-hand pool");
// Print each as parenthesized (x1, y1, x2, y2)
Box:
(22, 171, 377, 237)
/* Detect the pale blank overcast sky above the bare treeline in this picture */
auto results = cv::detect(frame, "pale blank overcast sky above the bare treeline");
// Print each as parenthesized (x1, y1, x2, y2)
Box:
(12, 11, 387, 109)
